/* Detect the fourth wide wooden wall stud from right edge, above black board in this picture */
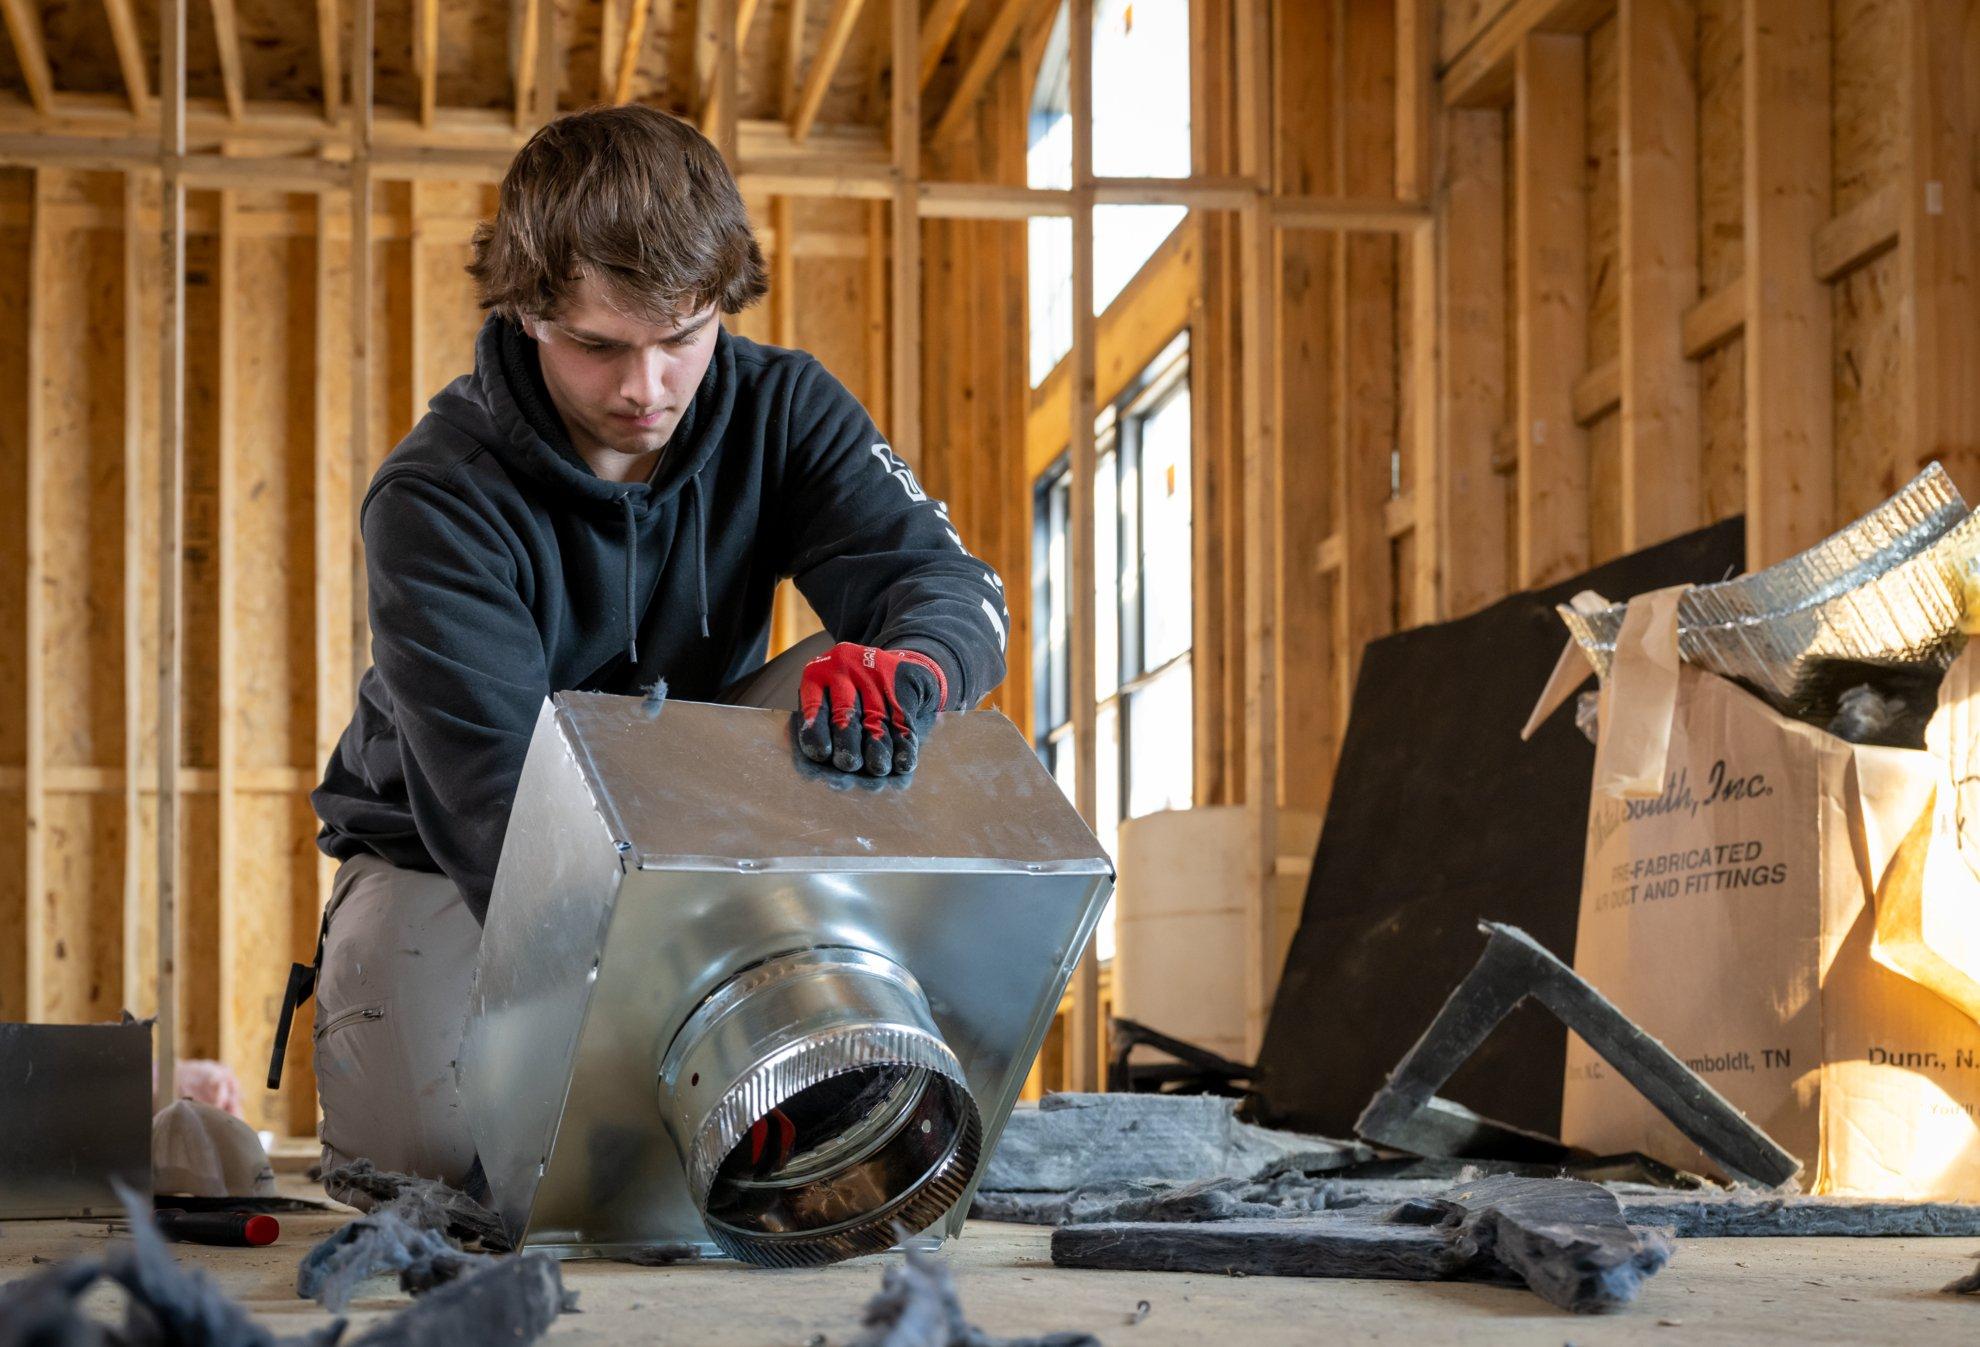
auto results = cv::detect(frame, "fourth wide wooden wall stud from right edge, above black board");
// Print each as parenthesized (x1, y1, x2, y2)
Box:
(1513, 32, 1588, 588)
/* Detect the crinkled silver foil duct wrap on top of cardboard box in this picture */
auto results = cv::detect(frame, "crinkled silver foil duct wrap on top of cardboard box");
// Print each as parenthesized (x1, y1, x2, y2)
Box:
(1558, 464, 1980, 721)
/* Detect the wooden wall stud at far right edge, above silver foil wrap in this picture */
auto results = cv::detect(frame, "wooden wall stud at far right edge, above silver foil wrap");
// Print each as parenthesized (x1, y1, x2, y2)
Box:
(1899, 0, 1980, 499)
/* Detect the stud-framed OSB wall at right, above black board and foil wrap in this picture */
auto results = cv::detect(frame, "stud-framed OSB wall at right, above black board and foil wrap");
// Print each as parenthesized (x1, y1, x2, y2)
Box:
(1439, 0, 1980, 616)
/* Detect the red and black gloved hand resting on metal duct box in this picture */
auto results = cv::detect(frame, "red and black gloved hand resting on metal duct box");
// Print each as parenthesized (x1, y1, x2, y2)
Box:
(798, 642, 948, 777)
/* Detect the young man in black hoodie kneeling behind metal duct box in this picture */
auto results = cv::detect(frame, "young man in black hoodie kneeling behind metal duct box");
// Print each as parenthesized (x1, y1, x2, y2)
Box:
(301, 107, 1008, 1183)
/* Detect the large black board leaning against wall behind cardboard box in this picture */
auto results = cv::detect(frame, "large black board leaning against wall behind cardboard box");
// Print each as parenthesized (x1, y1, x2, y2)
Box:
(1257, 517, 1746, 1137)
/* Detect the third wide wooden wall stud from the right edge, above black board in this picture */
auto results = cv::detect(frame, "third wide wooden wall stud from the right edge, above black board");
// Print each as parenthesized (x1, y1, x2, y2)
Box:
(1623, 0, 1705, 553)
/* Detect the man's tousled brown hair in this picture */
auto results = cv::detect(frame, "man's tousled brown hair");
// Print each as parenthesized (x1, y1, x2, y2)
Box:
(467, 103, 768, 321)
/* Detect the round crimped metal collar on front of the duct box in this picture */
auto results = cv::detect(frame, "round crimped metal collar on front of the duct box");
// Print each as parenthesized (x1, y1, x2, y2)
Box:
(659, 949, 982, 1268)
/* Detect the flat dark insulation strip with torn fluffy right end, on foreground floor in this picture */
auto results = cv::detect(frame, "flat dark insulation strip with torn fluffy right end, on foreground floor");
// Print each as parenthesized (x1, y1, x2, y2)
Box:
(1051, 1175, 1671, 1313)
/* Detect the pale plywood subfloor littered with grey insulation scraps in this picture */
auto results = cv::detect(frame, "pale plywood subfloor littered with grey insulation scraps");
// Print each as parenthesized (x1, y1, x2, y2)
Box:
(0, 1189, 1980, 1347)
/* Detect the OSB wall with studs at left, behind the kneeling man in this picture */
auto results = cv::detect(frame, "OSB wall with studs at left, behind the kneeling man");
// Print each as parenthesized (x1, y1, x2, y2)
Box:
(0, 168, 885, 1135)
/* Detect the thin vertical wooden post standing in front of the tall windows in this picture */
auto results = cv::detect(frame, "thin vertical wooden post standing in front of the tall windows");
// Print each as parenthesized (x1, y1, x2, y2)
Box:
(1069, 0, 1113, 1089)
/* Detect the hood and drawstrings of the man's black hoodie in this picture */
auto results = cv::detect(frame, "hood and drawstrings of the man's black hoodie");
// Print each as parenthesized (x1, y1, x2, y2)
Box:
(430, 313, 737, 664)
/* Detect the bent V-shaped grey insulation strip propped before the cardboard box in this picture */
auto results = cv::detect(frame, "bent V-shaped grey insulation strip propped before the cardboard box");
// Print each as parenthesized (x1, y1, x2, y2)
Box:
(1354, 921, 1802, 1187)
